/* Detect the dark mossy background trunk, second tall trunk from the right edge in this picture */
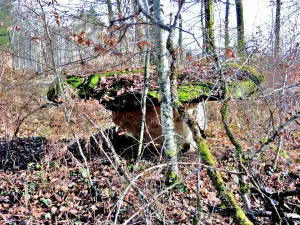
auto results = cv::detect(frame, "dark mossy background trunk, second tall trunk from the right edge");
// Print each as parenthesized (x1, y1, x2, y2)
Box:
(235, 0, 245, 54)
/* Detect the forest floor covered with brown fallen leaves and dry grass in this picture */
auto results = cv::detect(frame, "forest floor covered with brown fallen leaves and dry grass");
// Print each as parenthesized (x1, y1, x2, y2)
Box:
(0, 69, 300, 225)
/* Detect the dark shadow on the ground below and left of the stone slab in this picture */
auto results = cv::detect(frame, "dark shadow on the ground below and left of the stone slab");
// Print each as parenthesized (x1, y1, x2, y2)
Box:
(0, 127, 160, 170)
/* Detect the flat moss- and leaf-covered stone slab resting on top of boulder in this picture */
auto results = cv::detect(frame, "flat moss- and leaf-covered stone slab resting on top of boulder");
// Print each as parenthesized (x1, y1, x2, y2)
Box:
(47, 63, 264, 111)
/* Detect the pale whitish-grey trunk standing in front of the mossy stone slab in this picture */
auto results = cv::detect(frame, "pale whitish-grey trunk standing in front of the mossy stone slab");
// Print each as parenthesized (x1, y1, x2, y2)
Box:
(154, 0, 178, 185)
